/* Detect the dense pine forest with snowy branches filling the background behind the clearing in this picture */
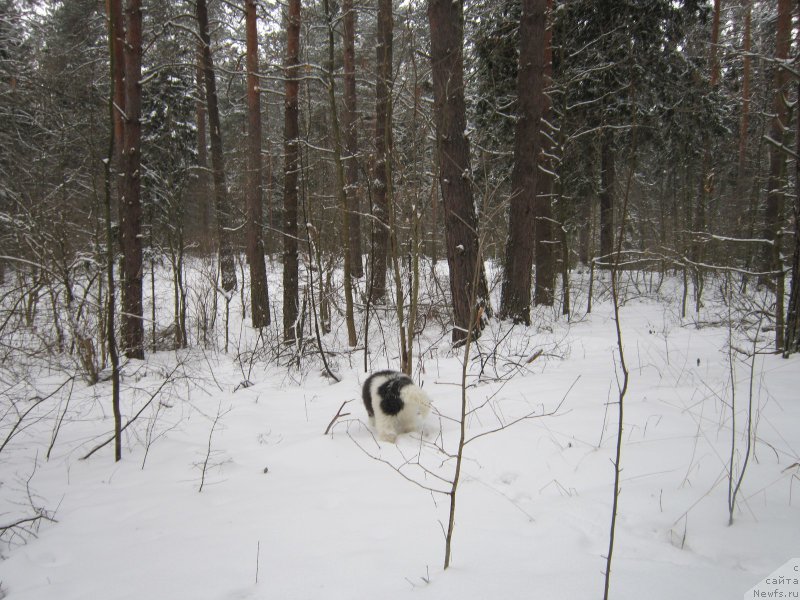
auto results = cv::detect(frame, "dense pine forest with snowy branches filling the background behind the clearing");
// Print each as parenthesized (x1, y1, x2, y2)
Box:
(0, 0, 800, 381)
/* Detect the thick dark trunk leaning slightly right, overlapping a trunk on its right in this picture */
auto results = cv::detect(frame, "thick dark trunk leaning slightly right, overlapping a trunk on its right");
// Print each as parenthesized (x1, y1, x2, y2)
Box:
(500, 0, 549, 325)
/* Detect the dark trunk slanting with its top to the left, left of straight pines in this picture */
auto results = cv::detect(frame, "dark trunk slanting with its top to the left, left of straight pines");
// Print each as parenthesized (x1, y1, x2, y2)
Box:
(196, 0, 236, 293)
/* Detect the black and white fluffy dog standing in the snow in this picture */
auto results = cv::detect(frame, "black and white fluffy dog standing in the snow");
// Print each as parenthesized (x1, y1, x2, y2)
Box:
(361, 371, 431, 442)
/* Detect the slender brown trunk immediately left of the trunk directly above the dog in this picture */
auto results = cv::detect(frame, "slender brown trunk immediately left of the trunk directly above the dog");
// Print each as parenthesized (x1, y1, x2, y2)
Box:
(342, 0, 364, 277)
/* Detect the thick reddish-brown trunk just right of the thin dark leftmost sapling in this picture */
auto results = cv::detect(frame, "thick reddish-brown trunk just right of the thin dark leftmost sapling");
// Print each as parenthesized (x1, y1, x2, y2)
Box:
(119, 0, 144, 359)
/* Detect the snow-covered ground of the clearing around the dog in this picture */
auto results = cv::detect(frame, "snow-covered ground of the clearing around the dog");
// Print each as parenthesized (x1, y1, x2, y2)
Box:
(0, 268, 800, 600)
